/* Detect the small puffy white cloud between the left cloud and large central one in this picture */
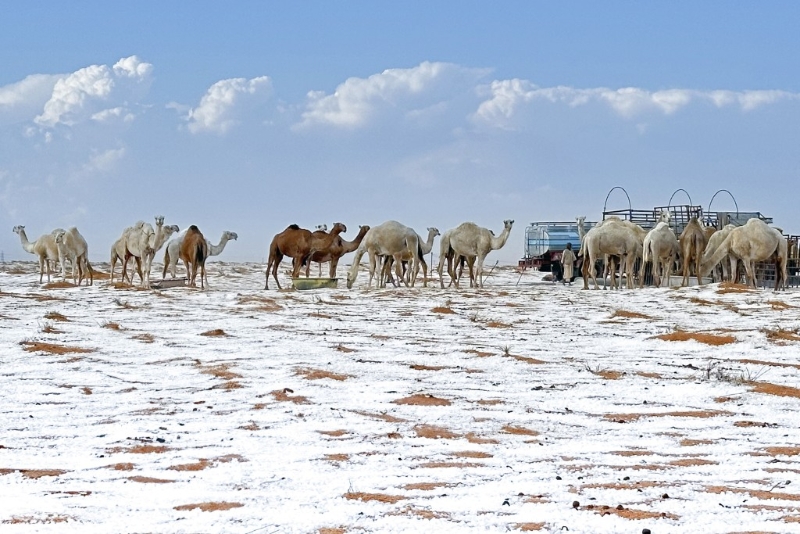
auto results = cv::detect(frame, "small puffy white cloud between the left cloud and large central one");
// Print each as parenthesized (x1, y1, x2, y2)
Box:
(186, 76, 272, 134)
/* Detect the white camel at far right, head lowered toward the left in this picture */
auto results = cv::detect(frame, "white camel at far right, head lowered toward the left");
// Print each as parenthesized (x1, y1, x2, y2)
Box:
(698, 218, 788, 291)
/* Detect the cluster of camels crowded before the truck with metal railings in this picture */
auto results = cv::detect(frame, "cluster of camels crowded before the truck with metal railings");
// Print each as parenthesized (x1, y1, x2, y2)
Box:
(577, 211, 788, 291)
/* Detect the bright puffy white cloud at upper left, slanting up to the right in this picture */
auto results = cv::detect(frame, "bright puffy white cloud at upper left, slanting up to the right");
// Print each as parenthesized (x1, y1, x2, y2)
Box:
(34, 56, 153, 128)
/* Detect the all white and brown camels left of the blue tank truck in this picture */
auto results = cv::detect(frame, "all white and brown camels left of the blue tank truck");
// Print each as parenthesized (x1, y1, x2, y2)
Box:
(14, 216, 514, 289)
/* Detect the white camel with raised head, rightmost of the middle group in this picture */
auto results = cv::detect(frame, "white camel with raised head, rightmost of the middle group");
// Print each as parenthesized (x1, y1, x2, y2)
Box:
(439, 219, 514, 288)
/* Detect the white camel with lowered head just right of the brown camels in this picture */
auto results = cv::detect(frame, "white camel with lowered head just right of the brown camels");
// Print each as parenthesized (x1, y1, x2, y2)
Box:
(347, 221, 420, 289)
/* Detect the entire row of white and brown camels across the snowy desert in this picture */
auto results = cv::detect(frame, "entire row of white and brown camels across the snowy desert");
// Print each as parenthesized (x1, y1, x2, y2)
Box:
(13, 211, 788, 291)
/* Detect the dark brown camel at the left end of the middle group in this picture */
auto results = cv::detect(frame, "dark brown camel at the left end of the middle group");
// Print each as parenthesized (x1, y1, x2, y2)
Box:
(264, 223, 347, 289)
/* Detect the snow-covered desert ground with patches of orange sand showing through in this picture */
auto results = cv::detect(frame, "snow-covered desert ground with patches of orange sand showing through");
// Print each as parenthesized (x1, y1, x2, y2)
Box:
(0, 262, 800, 534)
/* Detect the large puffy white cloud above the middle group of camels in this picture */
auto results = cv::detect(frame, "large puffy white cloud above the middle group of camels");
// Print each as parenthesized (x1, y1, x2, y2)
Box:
(298, 61, 488, 128)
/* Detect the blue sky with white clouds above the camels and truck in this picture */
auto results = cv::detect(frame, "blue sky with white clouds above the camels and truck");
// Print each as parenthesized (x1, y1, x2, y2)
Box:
(0, 1, 800, 262)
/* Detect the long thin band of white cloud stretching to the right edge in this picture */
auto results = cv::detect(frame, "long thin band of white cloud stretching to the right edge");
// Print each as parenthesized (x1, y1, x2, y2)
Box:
(472, 79, 800, 129)
